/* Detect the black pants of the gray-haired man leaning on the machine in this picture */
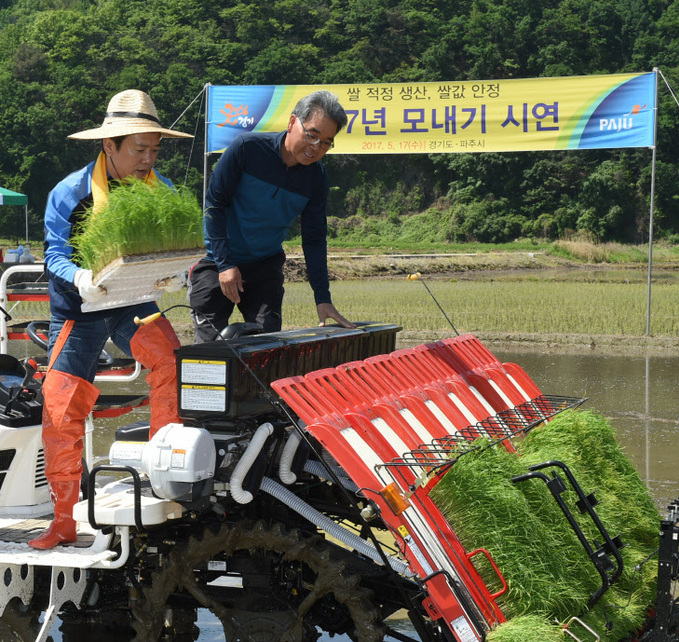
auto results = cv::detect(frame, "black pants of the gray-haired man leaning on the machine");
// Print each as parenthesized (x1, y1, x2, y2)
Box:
(188, 252, 285, 343)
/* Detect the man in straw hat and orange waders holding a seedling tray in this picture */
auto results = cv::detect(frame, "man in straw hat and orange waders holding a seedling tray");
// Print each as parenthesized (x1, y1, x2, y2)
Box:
(29, 89, 192, 549)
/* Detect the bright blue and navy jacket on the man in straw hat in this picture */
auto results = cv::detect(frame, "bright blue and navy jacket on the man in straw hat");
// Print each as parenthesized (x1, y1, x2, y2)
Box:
(45, 161, 172, 320)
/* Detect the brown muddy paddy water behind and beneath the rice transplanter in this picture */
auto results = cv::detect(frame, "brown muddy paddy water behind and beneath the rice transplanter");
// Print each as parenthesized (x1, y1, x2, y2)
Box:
(30, 342, 679, 642)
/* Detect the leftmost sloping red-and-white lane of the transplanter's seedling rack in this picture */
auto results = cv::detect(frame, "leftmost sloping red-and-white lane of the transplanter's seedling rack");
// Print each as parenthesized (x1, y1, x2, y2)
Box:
(272, 377, 504, 640)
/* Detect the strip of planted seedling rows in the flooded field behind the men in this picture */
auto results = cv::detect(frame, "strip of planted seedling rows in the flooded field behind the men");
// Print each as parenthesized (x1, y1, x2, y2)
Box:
(283, 278, 679, 336)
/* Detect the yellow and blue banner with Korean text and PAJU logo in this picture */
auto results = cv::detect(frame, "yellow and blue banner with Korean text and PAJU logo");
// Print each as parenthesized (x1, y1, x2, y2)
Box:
(207, 73, 656, 154)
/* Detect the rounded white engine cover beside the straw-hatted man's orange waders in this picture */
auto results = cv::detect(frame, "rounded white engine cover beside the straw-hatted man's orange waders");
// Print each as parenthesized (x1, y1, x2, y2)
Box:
(109, 424, 216, 499)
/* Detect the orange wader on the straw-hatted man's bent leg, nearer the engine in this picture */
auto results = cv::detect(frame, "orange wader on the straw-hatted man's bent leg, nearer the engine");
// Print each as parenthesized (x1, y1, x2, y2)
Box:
(130, 317, 181, 439)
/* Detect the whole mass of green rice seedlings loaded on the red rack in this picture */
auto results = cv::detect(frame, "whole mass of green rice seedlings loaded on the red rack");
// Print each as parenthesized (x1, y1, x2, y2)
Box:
(432, 411, 660, 642)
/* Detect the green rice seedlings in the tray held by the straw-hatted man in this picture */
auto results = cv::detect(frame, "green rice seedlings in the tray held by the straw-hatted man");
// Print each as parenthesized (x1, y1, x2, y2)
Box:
(72, 180, 203, 274)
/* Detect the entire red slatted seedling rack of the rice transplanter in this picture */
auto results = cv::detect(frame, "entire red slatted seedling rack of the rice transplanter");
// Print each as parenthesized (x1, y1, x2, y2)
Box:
(271, 334, 576, 640)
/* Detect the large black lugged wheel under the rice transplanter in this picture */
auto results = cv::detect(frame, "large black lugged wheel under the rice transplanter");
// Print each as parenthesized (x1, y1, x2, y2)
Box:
(133, 522, 384, 642)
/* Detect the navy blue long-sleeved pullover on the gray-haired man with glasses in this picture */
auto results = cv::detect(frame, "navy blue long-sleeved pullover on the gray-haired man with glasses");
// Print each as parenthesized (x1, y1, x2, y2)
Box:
(204, 132, 331, 305)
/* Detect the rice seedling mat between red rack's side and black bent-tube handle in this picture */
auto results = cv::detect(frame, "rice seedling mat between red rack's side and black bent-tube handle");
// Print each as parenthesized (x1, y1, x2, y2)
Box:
(432, 448, 596, 619)
